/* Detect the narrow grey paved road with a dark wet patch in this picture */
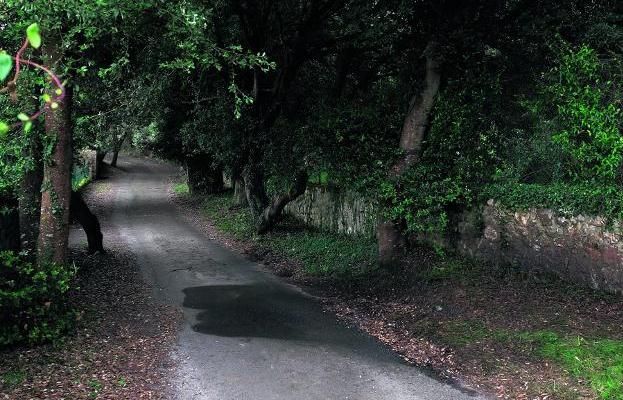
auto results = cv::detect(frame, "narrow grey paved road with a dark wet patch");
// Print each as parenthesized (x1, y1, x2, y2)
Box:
(106, 158, 486, 400)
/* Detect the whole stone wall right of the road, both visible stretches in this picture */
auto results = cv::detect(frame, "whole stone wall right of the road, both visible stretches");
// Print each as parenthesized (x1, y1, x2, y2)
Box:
(286, 187, 623, 293)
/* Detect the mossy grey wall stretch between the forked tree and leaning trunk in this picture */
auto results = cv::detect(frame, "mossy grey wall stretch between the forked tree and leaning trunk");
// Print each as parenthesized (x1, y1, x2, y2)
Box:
(285, 187, 376, 237)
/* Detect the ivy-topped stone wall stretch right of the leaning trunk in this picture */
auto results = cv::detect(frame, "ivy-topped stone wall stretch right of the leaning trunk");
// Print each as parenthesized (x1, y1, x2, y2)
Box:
(453, 200, 623, 293)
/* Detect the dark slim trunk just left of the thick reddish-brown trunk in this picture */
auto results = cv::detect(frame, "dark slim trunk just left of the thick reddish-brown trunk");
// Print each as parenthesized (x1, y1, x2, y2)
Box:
(19, 132, 43, 260)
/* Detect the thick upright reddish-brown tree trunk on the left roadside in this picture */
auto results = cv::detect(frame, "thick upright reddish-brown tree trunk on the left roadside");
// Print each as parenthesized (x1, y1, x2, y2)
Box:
(37, 39, 72, 264)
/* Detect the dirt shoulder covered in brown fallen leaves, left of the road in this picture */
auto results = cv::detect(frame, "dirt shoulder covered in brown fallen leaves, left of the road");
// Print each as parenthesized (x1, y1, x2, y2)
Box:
(0, 173, 180, 400)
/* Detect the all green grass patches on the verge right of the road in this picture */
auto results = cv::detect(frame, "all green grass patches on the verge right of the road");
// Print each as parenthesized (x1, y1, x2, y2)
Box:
(183, 184, 623, 400)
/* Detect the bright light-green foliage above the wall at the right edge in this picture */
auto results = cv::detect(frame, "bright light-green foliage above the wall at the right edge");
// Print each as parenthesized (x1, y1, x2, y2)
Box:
(526, 43, 623, 182)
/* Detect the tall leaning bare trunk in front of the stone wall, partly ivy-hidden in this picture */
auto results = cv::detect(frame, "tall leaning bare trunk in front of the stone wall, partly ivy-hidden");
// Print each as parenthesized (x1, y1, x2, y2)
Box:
(377, 40, 441, 268)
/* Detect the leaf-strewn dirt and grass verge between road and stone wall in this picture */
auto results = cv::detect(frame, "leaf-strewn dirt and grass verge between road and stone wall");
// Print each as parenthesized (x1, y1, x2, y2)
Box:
(173, 191, 623, 400)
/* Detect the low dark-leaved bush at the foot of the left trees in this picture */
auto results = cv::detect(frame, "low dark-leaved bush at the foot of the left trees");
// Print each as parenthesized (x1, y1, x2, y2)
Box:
(0, 251, 76, 347)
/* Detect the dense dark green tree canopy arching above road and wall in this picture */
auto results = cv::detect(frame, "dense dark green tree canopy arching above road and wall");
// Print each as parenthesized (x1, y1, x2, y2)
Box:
(0, 0, 623, 266)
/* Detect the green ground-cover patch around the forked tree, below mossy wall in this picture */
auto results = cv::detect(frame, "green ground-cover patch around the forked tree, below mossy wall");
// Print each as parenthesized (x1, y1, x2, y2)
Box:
(200, 192, 376, 278)
